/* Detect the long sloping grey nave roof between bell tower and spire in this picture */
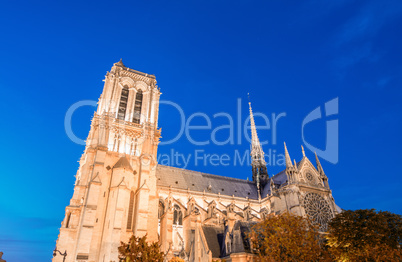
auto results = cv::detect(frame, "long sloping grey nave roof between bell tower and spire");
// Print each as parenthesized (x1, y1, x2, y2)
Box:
(156, 165, 258, 199)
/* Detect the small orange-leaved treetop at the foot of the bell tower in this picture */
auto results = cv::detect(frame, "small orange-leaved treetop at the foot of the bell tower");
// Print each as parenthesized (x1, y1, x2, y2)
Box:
(119, 235, 164, 262)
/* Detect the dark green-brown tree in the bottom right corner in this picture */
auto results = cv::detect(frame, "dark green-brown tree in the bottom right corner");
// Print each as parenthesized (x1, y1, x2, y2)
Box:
(327, 209, 402, 261)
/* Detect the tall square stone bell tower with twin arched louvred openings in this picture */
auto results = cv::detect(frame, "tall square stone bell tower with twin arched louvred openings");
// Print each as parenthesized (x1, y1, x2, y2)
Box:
(53, 60, 161, 262)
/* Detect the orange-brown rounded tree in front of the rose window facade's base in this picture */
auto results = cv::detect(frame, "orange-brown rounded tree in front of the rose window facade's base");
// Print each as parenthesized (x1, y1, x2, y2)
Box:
(250, 213, 329, 261)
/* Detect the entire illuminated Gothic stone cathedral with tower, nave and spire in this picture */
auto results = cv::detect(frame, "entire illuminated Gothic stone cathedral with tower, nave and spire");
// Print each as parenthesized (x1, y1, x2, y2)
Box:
(53, 60, 340, 262)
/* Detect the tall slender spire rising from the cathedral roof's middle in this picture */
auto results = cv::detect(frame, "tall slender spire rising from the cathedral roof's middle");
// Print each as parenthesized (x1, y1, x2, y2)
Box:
(248, 98, 268, 192)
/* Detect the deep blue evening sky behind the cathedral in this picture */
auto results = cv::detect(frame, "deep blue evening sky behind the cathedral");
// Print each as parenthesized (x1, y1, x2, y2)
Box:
(0, 0, 402, 262)
